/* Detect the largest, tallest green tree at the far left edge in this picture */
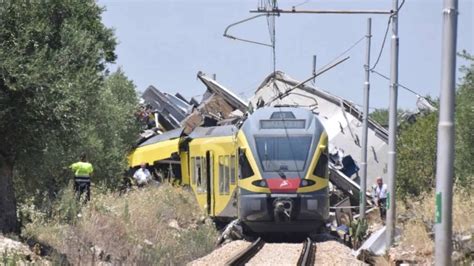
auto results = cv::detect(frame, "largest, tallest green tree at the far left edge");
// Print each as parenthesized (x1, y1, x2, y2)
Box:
(0, 0, 116, 232)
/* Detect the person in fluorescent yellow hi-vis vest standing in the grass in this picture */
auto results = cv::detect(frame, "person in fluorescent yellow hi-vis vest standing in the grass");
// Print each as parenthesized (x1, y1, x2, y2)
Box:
(70, 153, 94, 202)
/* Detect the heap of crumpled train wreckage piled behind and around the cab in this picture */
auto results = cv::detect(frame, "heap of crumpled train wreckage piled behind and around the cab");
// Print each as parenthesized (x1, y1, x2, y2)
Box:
(129, 71, 388, 216)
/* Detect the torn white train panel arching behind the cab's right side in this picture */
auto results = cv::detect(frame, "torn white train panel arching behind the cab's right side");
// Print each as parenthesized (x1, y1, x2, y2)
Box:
(250, 71, 388, 198)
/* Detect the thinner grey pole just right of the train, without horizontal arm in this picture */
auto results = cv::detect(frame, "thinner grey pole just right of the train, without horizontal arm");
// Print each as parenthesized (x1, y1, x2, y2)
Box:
(359, 18, 372, 220)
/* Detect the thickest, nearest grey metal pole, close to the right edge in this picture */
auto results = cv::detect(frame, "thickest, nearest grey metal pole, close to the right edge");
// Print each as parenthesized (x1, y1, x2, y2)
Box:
(435, 0, 458, 266)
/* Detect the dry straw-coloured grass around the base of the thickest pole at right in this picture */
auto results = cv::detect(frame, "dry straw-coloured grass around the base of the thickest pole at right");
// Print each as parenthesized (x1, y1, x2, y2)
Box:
(395, 189, 474, 263)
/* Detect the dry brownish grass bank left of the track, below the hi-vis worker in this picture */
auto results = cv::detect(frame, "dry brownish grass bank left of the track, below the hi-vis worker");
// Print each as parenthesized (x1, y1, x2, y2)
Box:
(24, 185, 217, 265)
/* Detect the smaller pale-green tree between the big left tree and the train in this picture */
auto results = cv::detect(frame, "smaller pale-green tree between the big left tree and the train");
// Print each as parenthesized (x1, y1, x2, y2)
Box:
(81, 69, 140, 186)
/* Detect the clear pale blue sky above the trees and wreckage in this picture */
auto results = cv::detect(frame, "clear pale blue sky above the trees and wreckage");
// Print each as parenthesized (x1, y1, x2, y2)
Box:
(98, 0, 474, 110)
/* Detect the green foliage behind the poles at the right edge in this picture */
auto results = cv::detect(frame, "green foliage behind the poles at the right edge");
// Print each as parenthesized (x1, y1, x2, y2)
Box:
(397, 52, 474, 197)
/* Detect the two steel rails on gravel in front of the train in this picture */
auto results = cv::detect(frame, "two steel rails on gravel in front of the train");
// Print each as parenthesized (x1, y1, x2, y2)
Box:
(225, 238, 316, 266)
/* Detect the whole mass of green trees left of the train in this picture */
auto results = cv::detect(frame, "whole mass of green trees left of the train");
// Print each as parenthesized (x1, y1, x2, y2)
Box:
(0, 0, 137, 231)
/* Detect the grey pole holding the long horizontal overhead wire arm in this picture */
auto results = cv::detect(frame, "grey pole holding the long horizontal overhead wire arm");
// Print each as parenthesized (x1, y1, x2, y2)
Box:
(386, 0, 399, 249)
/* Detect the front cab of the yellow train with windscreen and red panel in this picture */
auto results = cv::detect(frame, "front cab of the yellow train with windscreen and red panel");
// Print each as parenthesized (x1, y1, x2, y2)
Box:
(237, 107, 329, 232)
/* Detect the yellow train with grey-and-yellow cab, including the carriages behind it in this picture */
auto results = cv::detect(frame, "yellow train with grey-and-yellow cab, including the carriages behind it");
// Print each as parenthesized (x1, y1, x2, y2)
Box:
(129, 107, 329, 233)
